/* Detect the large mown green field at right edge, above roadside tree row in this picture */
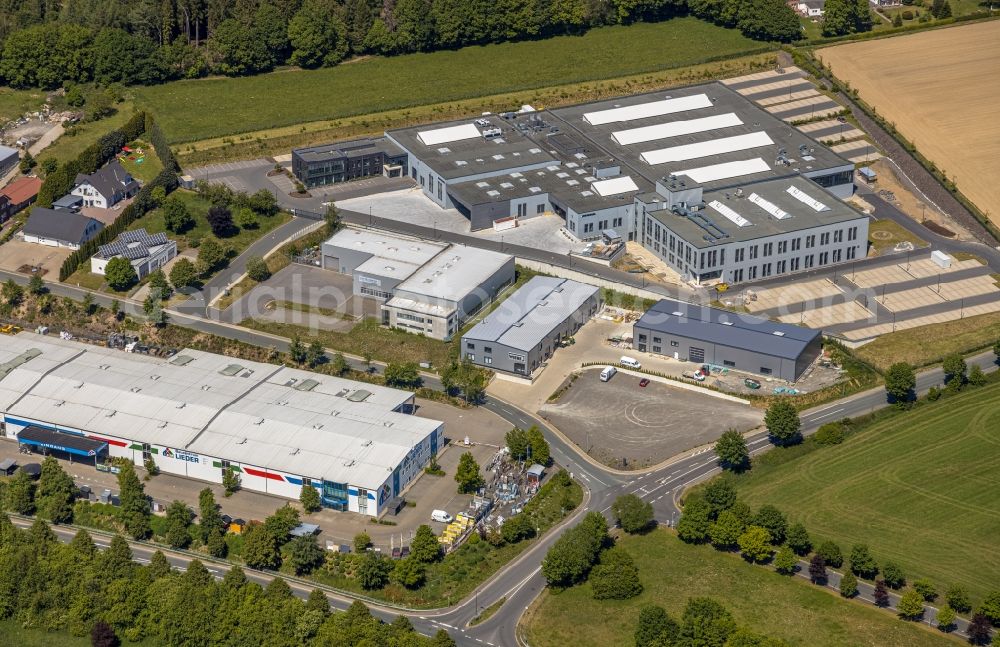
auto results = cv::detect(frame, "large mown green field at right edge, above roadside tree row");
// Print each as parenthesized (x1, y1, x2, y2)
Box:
(735, 383, 1000, 601)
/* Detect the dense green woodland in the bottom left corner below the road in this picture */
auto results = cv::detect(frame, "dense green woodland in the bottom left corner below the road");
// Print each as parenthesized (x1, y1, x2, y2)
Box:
(0, 514, 455, 647)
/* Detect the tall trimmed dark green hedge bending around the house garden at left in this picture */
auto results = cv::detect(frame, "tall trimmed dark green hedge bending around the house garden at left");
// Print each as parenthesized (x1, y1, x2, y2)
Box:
(58, 112, 178, 281)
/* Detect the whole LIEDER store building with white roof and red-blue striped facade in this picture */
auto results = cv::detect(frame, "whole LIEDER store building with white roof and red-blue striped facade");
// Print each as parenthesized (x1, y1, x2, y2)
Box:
(0, 333, 444, 517)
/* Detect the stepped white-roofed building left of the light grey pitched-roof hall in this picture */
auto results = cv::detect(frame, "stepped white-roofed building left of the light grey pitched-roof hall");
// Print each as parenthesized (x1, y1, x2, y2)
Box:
(322, 227, 514, 340)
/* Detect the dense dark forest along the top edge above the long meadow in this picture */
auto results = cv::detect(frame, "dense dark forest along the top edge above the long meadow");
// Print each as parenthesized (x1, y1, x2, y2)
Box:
(0, 0, 800, 89)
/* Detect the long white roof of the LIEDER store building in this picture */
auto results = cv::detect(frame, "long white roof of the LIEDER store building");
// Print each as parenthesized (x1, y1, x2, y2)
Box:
(0, 332, 442, 489)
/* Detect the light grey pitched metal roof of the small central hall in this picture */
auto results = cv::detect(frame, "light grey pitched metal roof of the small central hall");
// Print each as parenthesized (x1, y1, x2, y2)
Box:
(462, 276, 598, 351)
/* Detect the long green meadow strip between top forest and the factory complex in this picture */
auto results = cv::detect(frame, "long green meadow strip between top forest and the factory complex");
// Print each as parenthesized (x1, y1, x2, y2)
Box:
(135, 18, 767, 143)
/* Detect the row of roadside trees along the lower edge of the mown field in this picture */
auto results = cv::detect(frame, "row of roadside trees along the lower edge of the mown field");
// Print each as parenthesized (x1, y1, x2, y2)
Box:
(677, 478, 1000, 645)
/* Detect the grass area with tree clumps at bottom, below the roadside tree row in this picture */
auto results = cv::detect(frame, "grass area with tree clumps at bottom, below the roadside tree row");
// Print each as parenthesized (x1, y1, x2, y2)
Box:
(525, 530, 956, 647)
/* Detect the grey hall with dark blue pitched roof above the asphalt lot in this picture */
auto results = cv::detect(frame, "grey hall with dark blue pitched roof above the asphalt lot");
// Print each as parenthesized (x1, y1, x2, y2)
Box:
(633, 299, 823, 382)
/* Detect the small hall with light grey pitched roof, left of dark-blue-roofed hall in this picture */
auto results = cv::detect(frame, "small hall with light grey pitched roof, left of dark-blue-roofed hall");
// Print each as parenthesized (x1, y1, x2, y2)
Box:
(462, 276, 601, 376)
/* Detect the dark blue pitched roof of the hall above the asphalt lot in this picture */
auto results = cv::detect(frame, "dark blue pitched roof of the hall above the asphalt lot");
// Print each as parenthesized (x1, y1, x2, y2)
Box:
(635, 299, 823, 360)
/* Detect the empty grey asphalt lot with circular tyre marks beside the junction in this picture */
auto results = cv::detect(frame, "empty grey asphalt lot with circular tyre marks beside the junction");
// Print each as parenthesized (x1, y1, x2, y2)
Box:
(539, 368, 763, 469)
